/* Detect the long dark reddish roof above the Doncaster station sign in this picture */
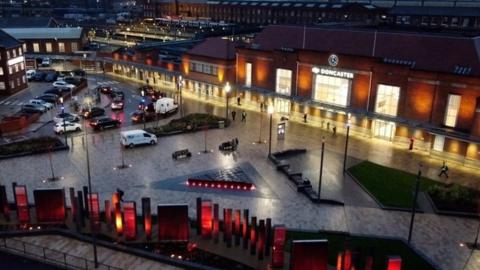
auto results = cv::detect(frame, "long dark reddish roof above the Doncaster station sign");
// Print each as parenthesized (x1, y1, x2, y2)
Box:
(251, 25, 480, 76)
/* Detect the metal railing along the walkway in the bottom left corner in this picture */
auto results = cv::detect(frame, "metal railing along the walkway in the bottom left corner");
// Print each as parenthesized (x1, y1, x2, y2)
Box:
(0, 238, 121, 270)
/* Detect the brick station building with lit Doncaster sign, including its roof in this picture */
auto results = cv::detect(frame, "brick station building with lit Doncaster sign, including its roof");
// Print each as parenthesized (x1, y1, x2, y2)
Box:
(237, 26, 480, 165)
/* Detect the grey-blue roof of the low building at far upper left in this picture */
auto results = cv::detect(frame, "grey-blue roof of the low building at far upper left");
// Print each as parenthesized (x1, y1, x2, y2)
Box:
(3, 27, 83, 39)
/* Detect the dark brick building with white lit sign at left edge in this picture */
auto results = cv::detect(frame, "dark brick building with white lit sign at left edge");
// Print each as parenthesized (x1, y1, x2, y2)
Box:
(0, 30, 27, 95)
